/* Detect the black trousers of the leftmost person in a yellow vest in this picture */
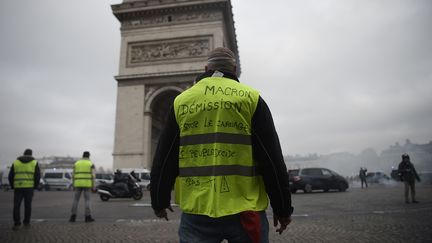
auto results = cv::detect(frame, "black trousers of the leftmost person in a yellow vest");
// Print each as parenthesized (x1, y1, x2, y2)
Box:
(13, 188, 33, 225)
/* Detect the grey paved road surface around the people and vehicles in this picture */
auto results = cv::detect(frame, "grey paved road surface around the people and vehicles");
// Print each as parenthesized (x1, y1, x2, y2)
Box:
(0, 182, 432, 242)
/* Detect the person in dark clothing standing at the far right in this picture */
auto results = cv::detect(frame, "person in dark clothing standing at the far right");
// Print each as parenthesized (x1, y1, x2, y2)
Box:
(398, 154, 420, 203)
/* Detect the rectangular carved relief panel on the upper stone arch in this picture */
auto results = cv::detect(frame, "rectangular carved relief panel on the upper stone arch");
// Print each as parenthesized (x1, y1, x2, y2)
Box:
(128, 36, 211, 65)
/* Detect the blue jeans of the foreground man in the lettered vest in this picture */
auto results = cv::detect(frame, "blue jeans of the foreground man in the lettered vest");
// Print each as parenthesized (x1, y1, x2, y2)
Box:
(178, 211, 269, 243)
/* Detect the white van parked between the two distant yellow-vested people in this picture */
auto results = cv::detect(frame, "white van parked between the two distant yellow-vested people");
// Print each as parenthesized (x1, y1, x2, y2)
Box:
(43, 169, 73, 191)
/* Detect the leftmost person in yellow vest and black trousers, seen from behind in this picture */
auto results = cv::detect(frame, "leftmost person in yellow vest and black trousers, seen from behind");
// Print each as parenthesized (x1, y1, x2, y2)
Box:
(8, 149, 40, 230)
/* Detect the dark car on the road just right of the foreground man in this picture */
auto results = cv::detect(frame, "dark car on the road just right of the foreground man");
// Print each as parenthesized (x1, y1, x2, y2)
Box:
(288, 168, 348, 193)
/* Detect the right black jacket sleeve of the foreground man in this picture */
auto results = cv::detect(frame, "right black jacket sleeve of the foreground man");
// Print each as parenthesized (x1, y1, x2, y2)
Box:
(252, 97, 293, 217)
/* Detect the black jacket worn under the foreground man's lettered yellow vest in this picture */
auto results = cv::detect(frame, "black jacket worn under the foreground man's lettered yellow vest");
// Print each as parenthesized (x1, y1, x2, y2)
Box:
(151, 71, 293, 217)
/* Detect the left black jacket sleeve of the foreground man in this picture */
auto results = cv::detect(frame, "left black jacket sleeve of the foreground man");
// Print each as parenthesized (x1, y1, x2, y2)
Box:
(150, 108, 180, 210)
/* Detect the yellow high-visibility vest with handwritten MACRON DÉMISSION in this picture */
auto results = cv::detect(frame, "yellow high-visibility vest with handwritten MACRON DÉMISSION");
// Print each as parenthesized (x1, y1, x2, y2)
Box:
(174, 77, 268, 218)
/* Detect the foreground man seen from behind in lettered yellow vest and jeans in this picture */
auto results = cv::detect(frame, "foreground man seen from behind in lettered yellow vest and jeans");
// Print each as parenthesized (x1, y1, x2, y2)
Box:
(151, 48, 293, 242)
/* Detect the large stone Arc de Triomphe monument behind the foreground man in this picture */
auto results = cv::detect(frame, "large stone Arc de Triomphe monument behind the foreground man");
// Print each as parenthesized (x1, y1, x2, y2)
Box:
(111, 0, 240, 169)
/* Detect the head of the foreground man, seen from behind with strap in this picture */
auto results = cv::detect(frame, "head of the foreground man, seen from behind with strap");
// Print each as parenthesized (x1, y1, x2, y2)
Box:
(205, 47, 237, 73)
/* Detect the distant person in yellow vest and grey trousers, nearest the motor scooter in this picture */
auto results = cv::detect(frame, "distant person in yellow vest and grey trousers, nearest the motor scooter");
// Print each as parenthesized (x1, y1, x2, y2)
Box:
(69, 151, 95, 222)
